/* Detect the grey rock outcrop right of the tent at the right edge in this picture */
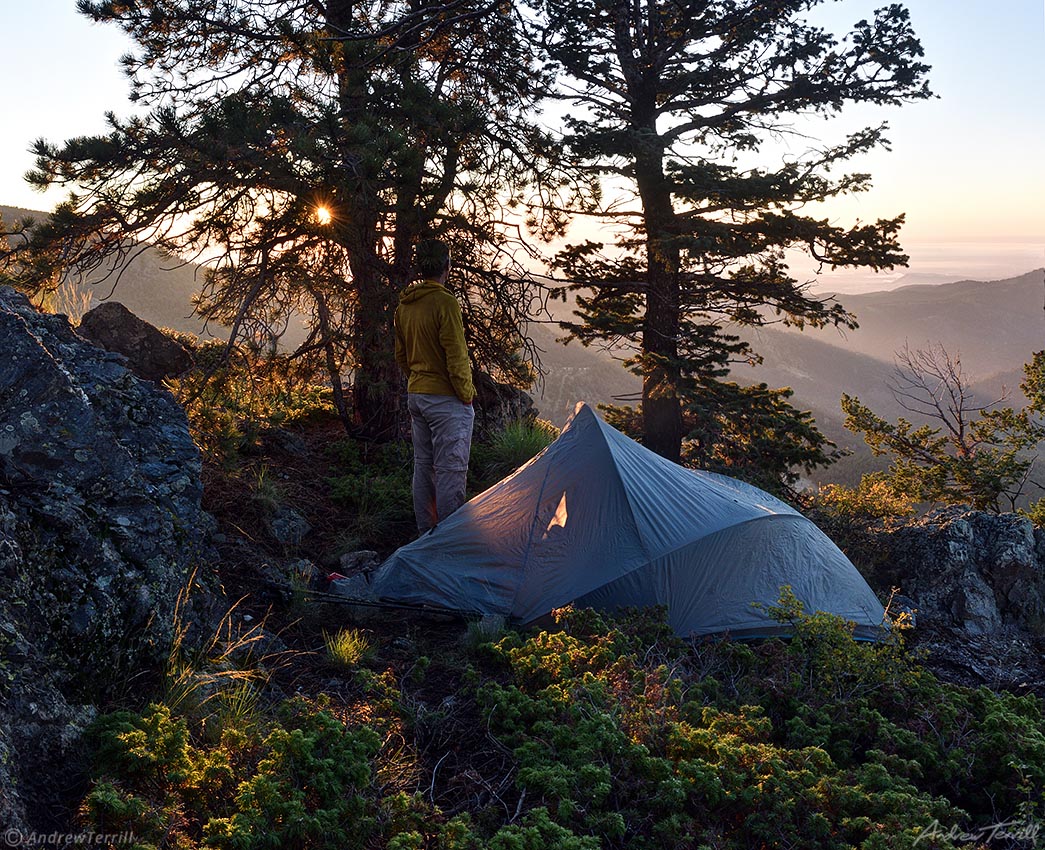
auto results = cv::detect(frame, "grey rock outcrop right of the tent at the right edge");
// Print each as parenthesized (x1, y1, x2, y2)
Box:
(858, 507, 1045, 635)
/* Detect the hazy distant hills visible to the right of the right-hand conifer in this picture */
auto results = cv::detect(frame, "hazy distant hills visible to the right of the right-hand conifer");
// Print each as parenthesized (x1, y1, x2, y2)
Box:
(733, 269, 1045, 484)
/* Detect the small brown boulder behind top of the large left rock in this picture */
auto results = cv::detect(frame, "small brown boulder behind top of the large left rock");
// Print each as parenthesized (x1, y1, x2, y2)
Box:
(77, 301, 192, 383)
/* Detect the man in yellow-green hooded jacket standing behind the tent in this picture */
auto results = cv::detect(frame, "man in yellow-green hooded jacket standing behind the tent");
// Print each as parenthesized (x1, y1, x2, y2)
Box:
(395, 239, 475, 534)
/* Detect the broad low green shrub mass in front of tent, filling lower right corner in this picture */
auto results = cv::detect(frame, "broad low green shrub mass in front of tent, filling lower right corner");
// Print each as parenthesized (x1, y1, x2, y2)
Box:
(480, 591, 1045, 850)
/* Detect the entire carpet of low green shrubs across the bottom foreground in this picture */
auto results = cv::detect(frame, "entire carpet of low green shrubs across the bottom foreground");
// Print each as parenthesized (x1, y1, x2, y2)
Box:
(80, 588, 1045, 850)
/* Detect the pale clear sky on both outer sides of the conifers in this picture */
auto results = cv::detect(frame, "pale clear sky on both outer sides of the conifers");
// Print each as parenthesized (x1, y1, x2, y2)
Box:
(0, 0, 1045, 288)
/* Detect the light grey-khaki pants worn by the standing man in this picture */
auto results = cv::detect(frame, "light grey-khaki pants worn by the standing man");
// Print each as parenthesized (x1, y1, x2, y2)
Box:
(407, 392, 475, 533)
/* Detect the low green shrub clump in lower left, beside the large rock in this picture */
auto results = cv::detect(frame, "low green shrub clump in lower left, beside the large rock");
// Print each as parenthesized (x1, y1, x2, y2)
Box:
(80, 699, 380, 850)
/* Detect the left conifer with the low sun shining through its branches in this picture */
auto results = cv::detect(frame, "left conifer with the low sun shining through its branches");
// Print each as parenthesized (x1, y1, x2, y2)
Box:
(16, 0, 548, 437)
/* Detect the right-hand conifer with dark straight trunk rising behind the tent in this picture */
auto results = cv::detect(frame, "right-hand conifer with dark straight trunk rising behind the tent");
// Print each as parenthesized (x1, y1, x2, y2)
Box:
(541, 0, 930, 461)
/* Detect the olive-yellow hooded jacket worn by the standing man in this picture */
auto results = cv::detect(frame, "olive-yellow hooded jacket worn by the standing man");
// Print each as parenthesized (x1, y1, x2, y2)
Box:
(395, 280, 475, 404)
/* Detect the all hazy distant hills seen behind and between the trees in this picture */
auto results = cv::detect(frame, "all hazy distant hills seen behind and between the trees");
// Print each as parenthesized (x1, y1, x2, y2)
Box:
(8, 199, 1045, 483)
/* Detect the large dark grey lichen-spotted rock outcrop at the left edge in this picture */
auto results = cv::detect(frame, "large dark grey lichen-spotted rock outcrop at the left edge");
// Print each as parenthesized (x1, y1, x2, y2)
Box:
(0, 288, 208, 828)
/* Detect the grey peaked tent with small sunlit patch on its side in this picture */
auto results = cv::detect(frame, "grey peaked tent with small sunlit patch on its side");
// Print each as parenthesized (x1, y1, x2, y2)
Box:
(372, 403, 884, 637)
